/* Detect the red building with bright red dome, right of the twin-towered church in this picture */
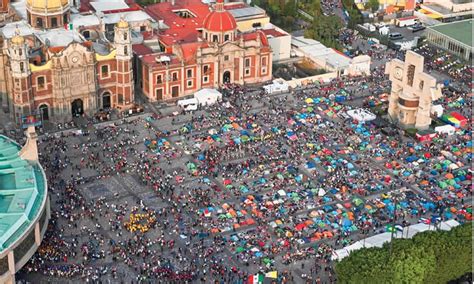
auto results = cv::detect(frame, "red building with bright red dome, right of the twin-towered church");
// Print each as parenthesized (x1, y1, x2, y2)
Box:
(135, 0, 272, 101)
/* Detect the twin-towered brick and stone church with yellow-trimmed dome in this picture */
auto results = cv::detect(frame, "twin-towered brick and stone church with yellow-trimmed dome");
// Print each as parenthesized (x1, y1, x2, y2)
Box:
(0, 0, 134, 122)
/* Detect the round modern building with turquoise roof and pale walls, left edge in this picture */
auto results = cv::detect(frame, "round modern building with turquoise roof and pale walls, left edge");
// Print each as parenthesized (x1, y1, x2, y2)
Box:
(0, 127, 51, 283)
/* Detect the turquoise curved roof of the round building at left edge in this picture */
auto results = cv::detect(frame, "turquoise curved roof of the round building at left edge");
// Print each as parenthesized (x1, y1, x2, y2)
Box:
(0, 135, 47, 252)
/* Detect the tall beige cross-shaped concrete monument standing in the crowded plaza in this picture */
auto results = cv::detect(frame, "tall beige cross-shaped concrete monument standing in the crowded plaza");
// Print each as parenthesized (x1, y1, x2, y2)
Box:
(385, 51, 442, 130)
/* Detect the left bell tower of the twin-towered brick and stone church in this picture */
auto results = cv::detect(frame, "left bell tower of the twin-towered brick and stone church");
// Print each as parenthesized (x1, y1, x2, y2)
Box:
(8, 29, 34, 121)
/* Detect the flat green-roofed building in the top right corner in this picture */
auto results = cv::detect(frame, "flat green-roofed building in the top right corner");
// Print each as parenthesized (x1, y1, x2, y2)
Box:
(425, 19, 473, 61)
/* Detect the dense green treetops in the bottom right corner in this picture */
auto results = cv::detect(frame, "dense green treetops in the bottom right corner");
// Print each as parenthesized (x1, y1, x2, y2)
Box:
(336, 223, 472, 283)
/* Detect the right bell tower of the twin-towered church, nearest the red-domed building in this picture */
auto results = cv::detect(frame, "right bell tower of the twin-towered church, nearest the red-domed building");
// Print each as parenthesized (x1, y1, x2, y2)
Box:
(114, 18, 135, 109)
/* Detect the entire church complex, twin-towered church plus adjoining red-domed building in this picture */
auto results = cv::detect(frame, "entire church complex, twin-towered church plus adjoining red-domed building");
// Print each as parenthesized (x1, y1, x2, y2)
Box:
(0, 0, 272, 123)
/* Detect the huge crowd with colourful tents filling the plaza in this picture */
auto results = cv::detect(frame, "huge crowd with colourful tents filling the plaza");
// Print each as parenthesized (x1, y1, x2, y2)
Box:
(13, 47, 472, 283)
